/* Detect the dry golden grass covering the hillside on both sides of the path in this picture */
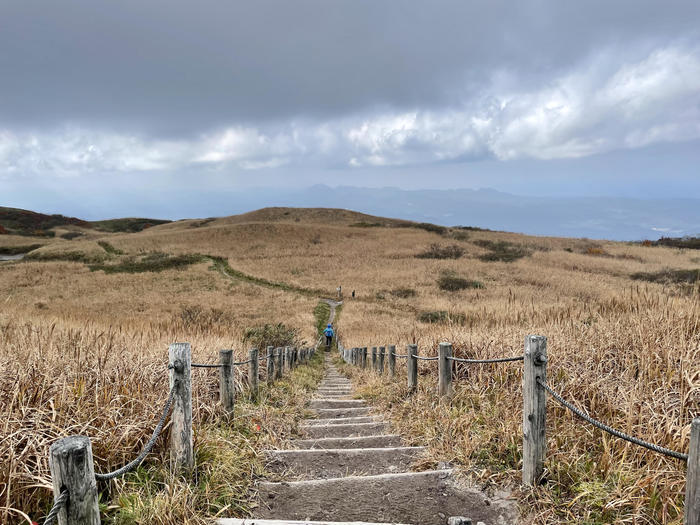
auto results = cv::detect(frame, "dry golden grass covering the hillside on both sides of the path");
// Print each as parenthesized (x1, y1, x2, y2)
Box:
(0, 208, 700, 523)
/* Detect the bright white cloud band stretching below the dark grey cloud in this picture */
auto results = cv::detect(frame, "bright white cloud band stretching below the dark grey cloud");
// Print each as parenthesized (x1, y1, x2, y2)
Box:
(0, 46, 700, 177)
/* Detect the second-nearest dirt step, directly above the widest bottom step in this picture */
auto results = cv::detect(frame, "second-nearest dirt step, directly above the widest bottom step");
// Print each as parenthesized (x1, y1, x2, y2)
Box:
(267, 447, 425, 479)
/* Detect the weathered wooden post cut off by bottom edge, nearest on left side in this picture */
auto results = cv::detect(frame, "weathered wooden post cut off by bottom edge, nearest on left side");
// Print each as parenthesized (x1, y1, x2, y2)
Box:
(49, 436, 100, 525)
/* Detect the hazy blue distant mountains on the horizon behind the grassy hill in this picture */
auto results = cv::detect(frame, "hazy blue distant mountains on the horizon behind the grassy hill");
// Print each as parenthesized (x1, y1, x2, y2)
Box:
(197, 185, 700, 240)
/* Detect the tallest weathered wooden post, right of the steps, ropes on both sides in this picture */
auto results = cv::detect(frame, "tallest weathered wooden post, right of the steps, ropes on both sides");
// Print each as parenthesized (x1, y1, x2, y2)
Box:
(523, 335, 547, 485)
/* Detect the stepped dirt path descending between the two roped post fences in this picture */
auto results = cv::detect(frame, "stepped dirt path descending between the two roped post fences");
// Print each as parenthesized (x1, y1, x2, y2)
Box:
(218, 352, 519, 525)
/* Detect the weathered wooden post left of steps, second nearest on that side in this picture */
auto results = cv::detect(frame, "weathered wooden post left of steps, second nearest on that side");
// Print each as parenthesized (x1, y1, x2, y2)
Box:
(168, 343, 194, 471)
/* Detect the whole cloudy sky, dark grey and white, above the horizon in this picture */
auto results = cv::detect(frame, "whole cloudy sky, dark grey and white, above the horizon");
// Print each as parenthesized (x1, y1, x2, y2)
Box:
(0, 0, 700, 235)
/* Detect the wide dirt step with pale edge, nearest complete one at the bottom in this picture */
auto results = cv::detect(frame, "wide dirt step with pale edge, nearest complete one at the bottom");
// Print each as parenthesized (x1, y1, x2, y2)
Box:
(254, 470, 520, 525)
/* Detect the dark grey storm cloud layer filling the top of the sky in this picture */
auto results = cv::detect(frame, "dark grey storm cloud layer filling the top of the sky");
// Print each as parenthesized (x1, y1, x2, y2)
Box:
(0, 0, 700, 137)
